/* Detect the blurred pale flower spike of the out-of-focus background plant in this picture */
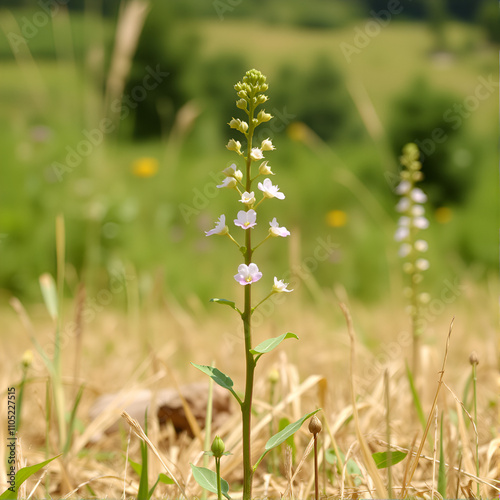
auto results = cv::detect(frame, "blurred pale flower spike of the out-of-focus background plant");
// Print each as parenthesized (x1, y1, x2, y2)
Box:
(394, 143, 430, 304)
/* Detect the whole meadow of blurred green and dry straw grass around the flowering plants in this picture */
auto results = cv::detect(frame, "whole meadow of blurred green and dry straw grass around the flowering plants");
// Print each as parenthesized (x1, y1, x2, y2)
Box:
(0, 2, 500, 499)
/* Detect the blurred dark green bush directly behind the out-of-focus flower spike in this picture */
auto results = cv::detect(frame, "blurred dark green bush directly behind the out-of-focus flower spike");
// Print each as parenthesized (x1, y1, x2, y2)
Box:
(388, 77, 474, 206)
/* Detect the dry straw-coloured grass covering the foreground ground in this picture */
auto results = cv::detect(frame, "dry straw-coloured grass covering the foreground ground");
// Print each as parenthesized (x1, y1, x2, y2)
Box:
(0, 278, 500, 498)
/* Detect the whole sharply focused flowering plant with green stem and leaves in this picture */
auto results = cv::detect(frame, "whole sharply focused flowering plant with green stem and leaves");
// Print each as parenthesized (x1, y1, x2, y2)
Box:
(189, 69, 318, 500)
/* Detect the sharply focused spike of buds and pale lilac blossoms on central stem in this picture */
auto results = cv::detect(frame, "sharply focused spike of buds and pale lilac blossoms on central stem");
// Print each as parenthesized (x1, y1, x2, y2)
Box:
(206, 69, 292, 294)
